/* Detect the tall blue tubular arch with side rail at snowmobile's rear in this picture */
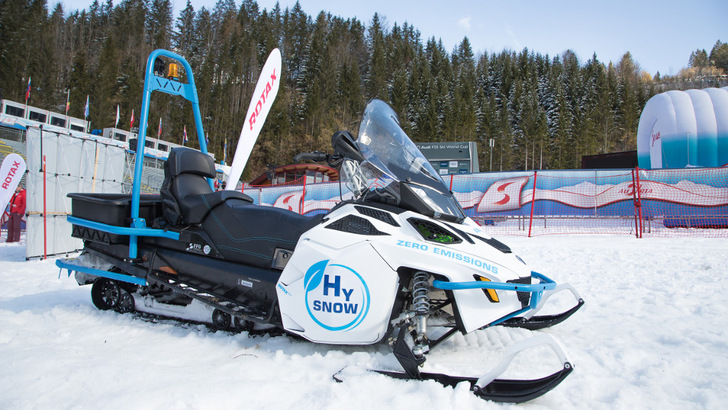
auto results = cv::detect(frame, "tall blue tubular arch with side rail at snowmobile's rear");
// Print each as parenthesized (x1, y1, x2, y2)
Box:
(61, 50, 213, 259)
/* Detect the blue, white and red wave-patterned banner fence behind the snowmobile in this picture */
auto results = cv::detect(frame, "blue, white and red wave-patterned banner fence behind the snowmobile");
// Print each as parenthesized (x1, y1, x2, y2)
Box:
(245, 168, 728, 238)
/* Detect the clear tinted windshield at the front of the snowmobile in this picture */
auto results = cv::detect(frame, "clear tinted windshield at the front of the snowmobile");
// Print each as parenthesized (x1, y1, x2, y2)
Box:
(348, 100, 464, 221)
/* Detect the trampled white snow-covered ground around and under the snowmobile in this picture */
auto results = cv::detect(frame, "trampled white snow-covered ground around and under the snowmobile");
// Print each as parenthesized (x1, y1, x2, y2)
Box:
(0, 235, 728, 409)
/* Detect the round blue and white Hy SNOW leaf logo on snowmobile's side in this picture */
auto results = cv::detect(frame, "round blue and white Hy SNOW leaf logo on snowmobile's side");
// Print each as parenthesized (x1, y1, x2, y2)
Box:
(303, 260, 370, 331)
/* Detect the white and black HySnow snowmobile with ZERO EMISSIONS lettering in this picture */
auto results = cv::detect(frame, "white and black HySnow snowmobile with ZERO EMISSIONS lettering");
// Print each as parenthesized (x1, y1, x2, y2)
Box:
(57, 49, 584, 402)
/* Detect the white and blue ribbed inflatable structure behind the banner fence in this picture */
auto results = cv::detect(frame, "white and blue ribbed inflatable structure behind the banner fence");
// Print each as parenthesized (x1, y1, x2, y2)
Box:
(637, 87, 728, 169)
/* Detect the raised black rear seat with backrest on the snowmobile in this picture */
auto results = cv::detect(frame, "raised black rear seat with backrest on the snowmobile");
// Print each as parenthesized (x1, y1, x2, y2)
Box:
(159, 148, 253, 225)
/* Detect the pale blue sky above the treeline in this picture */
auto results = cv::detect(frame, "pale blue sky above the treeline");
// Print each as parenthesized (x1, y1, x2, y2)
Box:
(58, 0, 728, 75)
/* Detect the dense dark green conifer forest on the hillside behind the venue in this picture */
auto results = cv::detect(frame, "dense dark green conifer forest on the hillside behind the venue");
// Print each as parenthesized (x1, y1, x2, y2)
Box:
(0, 0, 728, 180)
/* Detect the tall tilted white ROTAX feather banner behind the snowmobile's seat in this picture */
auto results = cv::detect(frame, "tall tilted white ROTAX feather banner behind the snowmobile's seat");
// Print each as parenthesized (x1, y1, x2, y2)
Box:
(225, 48, 281, 190)
